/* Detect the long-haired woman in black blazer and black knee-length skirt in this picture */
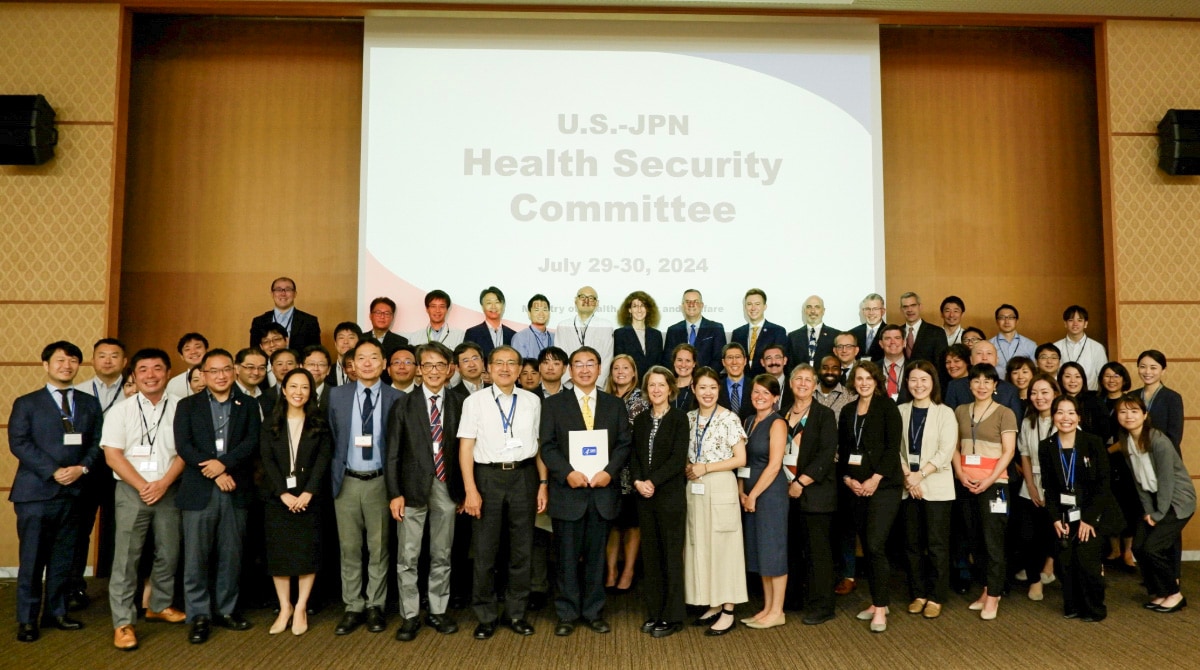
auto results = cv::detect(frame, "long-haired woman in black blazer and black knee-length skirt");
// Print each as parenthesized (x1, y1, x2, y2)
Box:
(259, 367, 334, 635)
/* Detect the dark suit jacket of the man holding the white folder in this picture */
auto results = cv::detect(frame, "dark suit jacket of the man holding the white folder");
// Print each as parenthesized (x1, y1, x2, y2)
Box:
(539, 390, 634, 521)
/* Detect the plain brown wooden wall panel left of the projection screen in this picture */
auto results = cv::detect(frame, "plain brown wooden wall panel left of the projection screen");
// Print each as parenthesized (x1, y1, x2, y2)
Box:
(120, 17, 362, 363)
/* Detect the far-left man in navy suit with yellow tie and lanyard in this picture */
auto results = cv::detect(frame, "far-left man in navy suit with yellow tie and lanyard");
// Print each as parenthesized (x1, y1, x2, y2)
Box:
(8, 341, 103, 642)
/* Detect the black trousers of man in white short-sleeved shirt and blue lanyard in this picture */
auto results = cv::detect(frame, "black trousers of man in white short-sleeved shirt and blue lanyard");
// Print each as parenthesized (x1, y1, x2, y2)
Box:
(470, 465, 538, 623)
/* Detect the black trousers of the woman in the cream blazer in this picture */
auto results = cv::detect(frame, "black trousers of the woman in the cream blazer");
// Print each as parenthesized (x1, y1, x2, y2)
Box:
(904, 498, 954, 603)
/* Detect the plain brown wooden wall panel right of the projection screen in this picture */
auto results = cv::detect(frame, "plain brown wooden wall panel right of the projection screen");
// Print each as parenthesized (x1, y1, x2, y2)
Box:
(880, 28, 1106, 342)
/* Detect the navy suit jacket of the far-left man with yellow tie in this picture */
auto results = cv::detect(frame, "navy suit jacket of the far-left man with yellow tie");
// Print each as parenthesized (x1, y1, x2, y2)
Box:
(8, 385, 104, 502)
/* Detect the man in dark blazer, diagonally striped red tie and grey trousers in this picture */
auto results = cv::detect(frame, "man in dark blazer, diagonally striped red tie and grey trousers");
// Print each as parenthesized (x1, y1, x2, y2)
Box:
(384, 342, 463, 642)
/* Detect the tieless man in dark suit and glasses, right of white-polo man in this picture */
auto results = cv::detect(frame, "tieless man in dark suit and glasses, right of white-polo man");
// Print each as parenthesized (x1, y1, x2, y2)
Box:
(174, 349, 262, 645)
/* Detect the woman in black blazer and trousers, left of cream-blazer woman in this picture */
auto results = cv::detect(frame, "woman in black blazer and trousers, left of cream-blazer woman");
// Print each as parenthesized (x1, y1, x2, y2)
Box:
(838, 361, 904, 633)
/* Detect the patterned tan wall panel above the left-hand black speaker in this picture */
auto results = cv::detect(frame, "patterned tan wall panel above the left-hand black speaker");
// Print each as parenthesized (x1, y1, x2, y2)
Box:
(0, 2, 121, 121)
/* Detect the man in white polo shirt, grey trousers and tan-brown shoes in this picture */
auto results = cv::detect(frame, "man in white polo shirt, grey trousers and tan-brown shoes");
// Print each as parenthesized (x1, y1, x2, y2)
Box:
(100, 349, 187, 650)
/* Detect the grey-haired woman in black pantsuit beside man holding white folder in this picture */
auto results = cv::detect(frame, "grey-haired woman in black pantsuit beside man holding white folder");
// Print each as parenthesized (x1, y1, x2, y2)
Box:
(630, 365, 689, 638)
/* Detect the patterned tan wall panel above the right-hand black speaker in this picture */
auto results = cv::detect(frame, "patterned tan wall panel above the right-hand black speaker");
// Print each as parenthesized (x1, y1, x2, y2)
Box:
(1108, 20, 1200, 132)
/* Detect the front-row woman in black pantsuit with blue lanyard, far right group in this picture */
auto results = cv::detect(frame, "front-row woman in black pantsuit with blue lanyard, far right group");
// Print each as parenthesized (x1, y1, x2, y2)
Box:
(1038, 395, 1124, 622)
